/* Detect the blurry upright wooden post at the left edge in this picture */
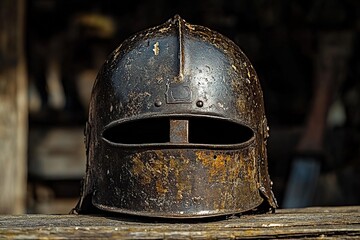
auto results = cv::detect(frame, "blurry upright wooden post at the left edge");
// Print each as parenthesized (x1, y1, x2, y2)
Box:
(0, 0, 27, 214)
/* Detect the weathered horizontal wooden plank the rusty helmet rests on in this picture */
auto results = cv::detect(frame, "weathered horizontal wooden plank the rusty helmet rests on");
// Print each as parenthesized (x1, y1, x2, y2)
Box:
(0, 206, 360, 239)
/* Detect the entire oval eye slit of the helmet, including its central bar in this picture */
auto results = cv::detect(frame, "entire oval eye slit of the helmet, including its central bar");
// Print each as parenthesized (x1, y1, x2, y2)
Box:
(103, 116, 254, 146)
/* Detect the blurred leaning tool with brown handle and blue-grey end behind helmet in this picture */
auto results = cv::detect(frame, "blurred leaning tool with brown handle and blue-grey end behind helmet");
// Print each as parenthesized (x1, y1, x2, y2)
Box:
(282, 31, 352, 208)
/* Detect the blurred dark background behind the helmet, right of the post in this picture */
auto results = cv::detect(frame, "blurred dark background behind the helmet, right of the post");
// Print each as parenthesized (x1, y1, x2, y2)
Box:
(20, 0, 360, 213)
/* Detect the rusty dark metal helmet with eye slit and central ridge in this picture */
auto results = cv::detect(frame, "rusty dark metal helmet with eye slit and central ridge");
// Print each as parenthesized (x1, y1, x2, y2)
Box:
(73, 15, 277, 218)
